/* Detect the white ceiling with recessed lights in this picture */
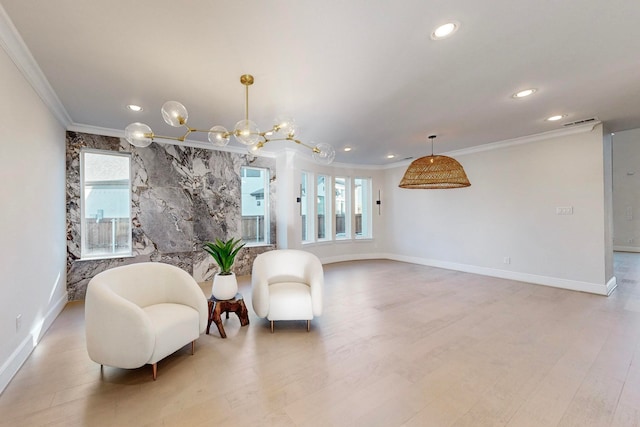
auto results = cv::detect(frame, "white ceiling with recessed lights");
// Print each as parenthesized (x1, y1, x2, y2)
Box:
(0, 0, 640, 165)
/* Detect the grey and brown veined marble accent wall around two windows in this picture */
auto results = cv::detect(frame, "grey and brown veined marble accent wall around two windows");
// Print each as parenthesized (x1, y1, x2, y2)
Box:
(66, 132, 276, 300)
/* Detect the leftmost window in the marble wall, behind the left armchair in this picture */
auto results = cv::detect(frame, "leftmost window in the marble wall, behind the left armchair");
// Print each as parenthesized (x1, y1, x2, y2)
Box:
(80, 149, 131, 259)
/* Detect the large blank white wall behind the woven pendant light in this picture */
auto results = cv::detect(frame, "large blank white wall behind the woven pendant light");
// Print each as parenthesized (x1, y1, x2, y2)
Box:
(384, 125, 615, 294)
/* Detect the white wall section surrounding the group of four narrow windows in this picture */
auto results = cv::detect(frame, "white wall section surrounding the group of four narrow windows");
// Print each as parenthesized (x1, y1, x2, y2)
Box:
(276, 150, 384, 263)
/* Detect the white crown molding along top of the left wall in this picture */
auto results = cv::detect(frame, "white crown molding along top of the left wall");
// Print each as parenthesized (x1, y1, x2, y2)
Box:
(0, 4, 72, 128)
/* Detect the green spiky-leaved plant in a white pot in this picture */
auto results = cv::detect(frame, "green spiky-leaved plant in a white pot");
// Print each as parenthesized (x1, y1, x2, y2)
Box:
(203, 238, 246, 300)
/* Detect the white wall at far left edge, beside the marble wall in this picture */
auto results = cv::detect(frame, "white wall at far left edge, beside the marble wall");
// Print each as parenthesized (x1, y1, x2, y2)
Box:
(0, 44, 67, 391)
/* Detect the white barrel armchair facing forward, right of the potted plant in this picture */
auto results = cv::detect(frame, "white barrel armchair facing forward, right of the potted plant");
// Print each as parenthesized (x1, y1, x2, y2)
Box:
(251, 249, 324, 332)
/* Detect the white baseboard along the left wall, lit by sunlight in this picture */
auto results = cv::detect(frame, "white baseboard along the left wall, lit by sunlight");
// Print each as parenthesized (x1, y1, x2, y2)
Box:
(0, 292, 69, 393)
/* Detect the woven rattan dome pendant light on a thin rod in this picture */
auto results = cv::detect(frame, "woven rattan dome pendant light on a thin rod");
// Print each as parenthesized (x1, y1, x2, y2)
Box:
(399, 135, 471, 189)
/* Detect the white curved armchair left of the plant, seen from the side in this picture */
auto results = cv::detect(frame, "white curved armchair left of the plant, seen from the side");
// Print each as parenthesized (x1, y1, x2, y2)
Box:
(85, 262, 208, 380)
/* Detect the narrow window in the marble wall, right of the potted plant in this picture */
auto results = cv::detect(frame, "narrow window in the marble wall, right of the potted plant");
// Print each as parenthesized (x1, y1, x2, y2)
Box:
(240, 166, 270, 246)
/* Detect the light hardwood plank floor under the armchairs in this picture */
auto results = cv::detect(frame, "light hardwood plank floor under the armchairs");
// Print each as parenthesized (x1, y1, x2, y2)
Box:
(0, 253, 640, 427)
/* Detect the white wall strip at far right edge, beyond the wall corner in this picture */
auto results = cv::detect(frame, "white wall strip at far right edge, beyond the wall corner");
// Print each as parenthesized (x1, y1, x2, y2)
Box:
(613, 129, 640, 252)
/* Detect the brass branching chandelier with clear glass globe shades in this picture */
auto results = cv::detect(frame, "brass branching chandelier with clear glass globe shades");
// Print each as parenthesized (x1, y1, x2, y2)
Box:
(124, 74, 336, 165)
